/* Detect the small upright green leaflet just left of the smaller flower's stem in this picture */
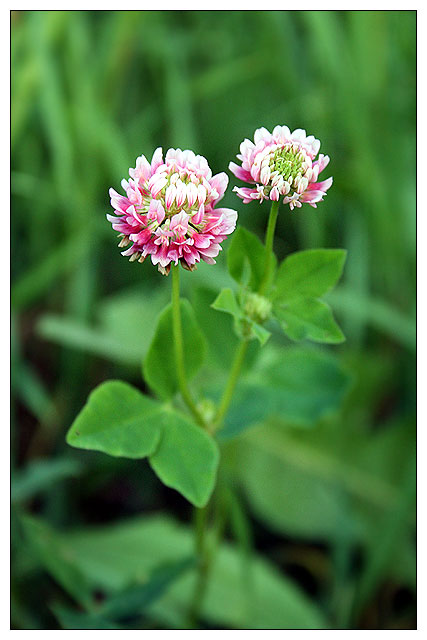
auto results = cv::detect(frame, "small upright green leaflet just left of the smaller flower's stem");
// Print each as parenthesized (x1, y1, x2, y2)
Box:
(227, 227, 265, 291)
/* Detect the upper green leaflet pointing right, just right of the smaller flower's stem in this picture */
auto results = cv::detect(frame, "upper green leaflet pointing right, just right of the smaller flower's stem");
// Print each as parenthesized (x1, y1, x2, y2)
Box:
(273, 249, 347, 302)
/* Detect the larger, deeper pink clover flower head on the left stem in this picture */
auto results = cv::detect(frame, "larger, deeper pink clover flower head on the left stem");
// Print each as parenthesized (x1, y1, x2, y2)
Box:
(107, 148, 237, 275)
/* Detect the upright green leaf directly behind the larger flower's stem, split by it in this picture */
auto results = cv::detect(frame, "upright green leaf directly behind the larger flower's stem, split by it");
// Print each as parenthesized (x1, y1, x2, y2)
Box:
(143, 299, 206, 399)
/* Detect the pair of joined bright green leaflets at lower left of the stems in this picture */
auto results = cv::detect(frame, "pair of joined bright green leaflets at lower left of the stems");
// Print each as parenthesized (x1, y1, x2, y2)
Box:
(67, 380, 219, 506)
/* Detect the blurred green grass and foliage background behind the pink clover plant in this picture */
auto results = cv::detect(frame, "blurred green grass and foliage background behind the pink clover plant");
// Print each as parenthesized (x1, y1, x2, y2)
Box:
(11, 11, 416, 629)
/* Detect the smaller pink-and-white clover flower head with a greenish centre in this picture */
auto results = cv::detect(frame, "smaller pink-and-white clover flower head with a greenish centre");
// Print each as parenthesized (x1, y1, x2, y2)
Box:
(229, 125, 332, 210)
